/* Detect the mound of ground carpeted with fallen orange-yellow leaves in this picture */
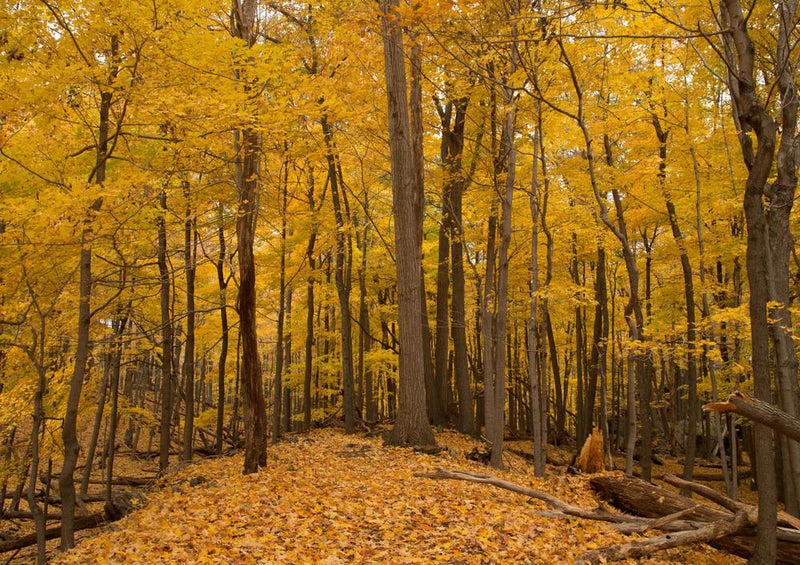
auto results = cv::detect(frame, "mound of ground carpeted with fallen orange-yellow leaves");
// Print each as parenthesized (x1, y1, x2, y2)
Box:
(55, 430, 742, 565)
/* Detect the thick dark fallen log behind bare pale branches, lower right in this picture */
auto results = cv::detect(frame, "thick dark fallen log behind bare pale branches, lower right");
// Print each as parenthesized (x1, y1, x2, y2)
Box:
(589, 475, 800, 565)
